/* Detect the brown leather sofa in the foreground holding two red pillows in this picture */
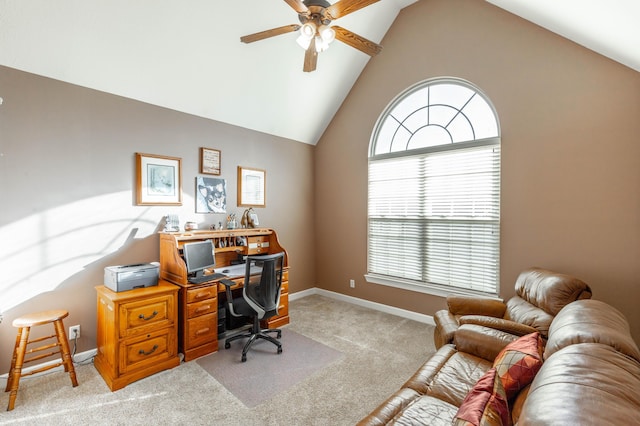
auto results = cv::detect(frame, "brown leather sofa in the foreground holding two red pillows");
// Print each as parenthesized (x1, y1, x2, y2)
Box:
(359, 300, 640, 426)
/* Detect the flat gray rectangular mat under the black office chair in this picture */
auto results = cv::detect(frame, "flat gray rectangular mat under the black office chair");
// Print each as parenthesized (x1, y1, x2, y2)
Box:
(196, 327, 343, 408)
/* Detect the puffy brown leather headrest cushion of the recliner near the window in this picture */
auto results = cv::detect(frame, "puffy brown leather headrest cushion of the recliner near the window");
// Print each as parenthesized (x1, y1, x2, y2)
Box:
(507, 268, 591, 316)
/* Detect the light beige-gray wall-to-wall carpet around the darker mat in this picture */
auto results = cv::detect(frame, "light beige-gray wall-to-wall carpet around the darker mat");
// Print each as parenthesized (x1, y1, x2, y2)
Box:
(0, 295, 435, 426)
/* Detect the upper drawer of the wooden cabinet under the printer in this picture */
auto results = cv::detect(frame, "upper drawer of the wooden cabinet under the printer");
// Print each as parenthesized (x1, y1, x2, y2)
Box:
(119, 295, 175, 337)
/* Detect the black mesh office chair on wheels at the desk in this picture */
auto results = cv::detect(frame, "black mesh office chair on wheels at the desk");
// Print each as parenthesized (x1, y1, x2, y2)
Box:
(220, 252, 284, 362)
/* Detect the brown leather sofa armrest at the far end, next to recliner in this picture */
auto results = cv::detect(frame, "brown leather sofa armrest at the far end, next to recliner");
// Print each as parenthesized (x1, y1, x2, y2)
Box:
(453, 324, 518, 362)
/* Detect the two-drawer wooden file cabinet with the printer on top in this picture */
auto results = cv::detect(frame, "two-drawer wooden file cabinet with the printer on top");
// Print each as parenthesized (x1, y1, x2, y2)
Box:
(94, 280, 180, 391)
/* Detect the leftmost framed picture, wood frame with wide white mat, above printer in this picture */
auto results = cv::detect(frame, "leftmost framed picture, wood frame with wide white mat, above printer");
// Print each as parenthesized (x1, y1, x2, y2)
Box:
(136, 152, 182, 206)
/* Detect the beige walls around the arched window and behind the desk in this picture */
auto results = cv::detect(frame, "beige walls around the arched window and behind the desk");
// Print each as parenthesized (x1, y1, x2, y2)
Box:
(0, 0, 640, 373)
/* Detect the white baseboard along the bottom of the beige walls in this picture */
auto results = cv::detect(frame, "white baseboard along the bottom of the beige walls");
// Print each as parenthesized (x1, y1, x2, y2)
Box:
(0, 287, 435, 380)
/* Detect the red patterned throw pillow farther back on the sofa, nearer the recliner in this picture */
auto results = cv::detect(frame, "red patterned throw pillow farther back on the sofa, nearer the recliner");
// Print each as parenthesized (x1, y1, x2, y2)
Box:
(493, 332, 544, 400)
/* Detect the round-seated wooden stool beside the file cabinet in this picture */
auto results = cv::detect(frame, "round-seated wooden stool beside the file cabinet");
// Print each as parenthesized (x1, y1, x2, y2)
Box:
(4, 310, 78, 411)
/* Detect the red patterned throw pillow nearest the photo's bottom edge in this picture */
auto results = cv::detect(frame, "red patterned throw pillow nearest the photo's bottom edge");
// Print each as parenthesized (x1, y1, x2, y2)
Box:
(452, 368, 511, 426)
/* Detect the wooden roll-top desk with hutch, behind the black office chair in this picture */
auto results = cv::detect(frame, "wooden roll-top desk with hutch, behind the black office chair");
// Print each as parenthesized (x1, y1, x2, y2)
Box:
(160, 228, 289, 361)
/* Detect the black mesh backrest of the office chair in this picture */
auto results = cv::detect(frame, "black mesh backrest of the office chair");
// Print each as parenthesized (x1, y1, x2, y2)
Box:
(243, 252, 284, 319)
